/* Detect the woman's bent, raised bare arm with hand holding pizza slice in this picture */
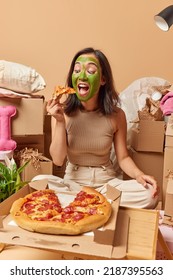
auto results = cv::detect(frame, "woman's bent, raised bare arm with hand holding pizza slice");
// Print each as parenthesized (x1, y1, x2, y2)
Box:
(46, 100, 67, 166)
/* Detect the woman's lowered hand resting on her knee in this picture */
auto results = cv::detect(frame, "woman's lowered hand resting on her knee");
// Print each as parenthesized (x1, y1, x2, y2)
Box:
(136, 174, 159, 198)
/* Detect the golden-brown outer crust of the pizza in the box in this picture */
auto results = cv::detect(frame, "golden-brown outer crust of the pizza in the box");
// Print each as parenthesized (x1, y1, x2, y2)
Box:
(10, 187, 112, 235)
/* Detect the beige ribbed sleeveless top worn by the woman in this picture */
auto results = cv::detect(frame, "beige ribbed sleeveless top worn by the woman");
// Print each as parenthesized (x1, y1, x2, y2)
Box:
(67, 110, 114, 166)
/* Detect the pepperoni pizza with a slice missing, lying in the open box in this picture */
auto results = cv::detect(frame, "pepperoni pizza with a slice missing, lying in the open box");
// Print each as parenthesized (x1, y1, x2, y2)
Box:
(10, 187, 112, 235)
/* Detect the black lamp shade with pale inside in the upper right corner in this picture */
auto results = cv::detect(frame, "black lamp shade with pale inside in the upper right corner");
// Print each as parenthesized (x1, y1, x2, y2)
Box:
(154, 5, 173, 31)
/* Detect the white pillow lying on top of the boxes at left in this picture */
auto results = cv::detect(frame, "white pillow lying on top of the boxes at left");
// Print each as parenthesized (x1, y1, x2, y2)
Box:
(0, 60, 46, 94)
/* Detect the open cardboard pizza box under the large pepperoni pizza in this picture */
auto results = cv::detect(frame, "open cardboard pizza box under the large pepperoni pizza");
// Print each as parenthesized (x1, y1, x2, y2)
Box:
(0, 180, 129, 259)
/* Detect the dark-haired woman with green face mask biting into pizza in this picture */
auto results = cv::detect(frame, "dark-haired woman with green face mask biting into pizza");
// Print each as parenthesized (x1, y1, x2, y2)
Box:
(47, 48, 158, 208)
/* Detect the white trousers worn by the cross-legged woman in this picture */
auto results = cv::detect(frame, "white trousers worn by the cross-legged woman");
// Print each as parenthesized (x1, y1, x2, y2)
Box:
(33, 163, 158, 209)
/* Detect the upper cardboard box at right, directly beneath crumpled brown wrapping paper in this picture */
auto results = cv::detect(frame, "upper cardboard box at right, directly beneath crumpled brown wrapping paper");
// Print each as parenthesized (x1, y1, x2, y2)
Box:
(130, 120, 165, 153)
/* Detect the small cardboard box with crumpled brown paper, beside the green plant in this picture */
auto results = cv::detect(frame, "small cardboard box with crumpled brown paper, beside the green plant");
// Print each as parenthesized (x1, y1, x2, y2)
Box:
(20, 156, 53, 181)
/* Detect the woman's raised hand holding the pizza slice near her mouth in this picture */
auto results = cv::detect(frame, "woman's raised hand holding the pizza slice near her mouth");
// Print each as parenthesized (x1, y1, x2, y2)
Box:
(46, 99, 65, 122)
